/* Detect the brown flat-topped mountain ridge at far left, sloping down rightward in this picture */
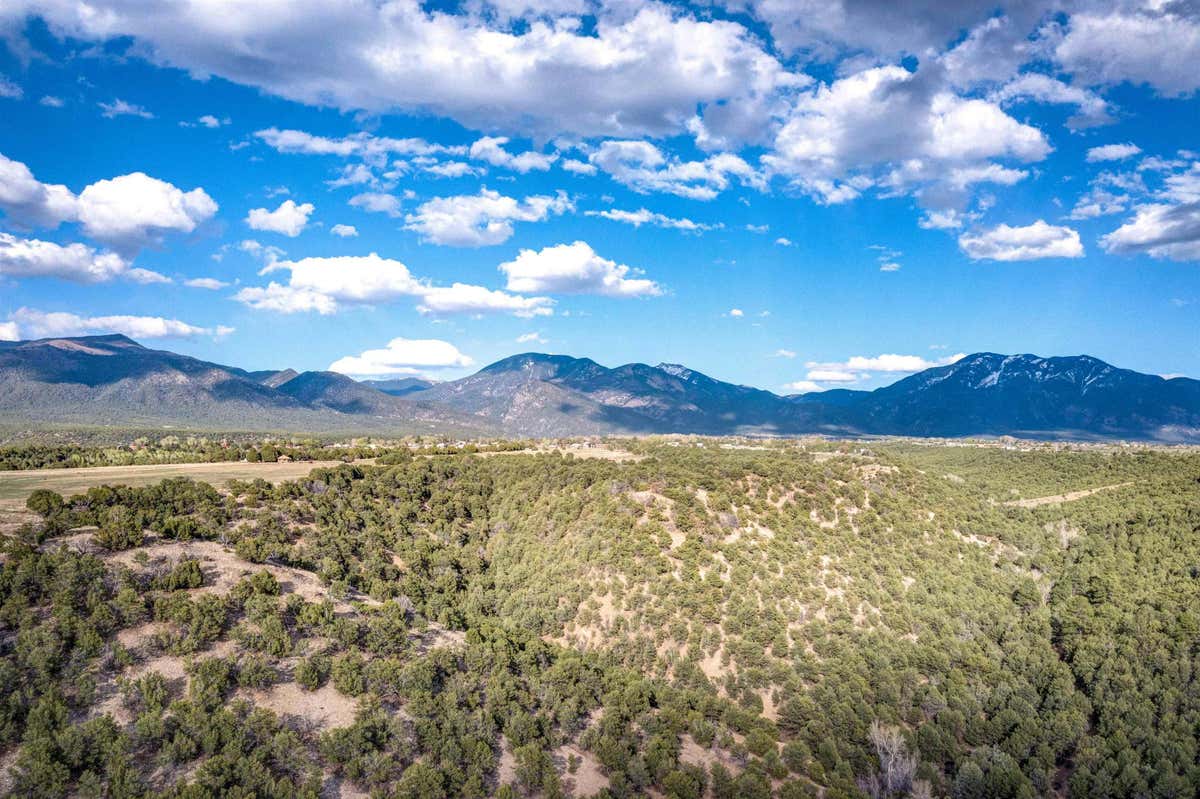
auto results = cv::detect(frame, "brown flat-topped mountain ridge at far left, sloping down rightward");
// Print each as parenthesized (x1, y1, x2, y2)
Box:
(0, 335, 491, 433)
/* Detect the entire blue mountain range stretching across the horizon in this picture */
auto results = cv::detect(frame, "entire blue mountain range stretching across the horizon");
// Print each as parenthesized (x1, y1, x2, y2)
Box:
(0, 335, 1200, 441)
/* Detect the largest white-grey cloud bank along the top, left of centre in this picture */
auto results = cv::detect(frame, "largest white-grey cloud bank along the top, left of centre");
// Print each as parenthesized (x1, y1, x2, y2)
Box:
(14, 0, 808, 141)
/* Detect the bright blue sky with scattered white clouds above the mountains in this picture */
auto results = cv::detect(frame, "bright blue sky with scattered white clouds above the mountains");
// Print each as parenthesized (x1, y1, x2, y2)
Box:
(0, 0, 1200, 391)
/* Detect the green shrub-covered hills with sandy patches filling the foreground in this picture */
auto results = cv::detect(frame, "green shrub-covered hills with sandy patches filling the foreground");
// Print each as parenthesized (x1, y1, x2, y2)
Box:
(0, 438, 1200, 799)
